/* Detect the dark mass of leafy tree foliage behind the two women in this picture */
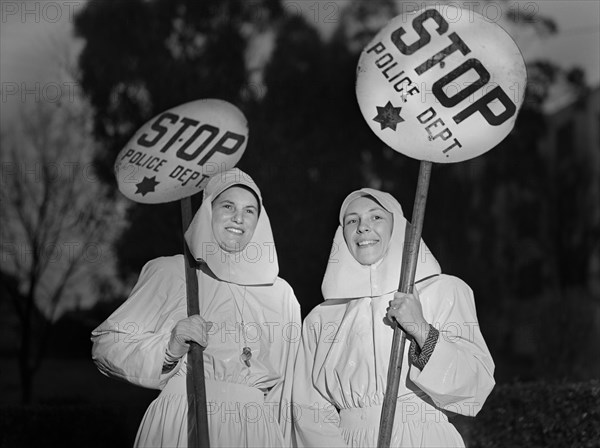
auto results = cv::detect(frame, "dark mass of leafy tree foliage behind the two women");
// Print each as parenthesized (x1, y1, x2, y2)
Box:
(77, 0, 598, 384)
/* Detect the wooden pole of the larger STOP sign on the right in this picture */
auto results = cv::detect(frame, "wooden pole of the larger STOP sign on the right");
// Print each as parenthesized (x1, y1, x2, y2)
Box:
(377, 161, 431, 448)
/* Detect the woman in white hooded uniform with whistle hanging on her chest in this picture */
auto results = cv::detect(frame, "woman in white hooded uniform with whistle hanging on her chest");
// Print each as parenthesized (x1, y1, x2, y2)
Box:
(92, 169, 300, 447)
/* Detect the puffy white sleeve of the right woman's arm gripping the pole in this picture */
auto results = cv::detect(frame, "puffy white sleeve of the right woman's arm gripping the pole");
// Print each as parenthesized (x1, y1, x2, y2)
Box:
(410, 276, 495, 416)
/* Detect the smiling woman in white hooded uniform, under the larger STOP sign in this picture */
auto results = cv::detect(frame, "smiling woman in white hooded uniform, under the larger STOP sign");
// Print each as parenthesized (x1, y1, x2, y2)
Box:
(292, 188, 494, 447)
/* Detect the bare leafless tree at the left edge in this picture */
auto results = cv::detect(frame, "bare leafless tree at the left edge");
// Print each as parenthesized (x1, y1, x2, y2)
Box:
(0, 94, 123, 400)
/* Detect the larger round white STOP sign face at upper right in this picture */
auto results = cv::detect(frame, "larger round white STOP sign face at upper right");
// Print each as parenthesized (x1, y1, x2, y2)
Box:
(356, 5, 527, 163)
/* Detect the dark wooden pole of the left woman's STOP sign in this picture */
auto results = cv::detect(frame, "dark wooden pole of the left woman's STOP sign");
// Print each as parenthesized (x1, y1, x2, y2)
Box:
(180, 197, 210, 448)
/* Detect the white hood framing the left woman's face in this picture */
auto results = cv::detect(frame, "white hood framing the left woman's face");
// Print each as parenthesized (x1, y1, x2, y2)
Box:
(185, 168, 279, 286)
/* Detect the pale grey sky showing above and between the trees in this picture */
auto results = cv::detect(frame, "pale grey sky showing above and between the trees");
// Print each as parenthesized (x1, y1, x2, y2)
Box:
(0, 0, 600, 105)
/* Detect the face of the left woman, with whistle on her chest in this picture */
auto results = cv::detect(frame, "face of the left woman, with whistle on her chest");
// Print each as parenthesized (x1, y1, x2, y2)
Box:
(212, 187, 259, 252)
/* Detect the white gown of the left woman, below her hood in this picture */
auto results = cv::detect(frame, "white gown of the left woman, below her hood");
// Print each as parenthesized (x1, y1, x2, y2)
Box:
(92, 255, 300, 447)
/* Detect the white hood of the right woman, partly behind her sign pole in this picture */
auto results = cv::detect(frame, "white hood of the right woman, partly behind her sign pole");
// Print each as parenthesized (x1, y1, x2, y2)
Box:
(321, 188, 441, 300)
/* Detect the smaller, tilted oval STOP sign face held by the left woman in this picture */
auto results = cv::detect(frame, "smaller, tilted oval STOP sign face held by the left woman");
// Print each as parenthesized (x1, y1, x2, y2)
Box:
(115, 99, 248, 204)
